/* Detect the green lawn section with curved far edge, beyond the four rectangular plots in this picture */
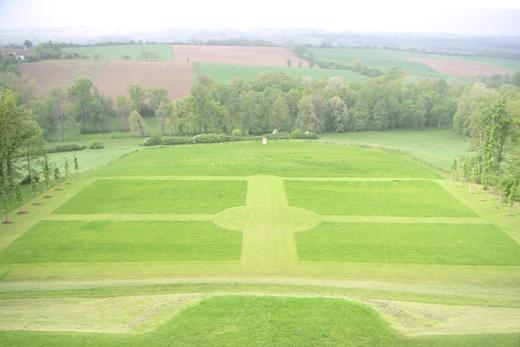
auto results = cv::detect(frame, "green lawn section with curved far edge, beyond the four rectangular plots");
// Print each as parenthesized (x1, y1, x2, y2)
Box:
(98, 141, 439, 178)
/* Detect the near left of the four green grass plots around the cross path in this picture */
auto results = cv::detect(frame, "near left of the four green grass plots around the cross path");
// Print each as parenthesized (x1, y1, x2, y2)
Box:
(0, 221, 242, 263)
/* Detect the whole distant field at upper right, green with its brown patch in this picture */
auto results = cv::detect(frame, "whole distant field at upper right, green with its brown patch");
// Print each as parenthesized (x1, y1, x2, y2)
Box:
(311, 48, 520, 78)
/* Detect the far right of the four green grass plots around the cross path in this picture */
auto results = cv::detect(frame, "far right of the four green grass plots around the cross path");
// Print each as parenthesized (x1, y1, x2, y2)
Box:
(285, 181, 476, 217)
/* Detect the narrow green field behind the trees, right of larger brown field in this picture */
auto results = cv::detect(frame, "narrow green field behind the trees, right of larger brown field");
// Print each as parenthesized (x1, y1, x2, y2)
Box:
(194, 63, 368, 83)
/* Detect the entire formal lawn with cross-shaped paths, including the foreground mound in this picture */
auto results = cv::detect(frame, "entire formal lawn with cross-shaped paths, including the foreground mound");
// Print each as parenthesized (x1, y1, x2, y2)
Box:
(0, 141, 520, 346)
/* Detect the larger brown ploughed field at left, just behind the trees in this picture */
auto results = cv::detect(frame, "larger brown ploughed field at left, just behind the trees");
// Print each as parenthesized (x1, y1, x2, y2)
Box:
(20, 60, 193, 98)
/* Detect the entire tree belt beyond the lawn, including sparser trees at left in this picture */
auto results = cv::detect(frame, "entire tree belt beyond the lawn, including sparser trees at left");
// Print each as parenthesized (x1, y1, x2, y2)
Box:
(22, 70, 462, 140)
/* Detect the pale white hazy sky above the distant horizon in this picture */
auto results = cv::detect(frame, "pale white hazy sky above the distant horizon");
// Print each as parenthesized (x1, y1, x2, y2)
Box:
(0, 0, 520, 35)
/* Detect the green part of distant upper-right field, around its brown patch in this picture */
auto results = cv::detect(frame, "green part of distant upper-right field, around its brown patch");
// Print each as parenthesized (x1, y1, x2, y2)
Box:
(311, 48, 520, 77)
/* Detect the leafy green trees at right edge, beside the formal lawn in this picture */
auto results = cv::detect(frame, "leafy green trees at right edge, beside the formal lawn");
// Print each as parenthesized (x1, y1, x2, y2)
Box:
(452, 83, 520, 204)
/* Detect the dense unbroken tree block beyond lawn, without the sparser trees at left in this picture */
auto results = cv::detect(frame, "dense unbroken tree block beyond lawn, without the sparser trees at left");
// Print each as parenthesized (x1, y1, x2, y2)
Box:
(157, 70, 460, 135)
